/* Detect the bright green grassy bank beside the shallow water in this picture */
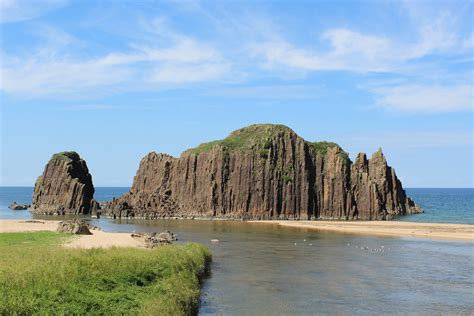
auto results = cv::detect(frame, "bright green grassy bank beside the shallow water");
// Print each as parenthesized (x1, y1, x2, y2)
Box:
(0, 232, 211, 315)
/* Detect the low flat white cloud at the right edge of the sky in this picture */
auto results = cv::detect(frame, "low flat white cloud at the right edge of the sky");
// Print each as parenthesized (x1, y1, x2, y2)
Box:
(375, 85, 474, 112)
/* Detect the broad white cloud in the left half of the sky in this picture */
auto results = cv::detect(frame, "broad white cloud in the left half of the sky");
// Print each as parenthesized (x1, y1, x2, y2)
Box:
(0, 23, 230, 96)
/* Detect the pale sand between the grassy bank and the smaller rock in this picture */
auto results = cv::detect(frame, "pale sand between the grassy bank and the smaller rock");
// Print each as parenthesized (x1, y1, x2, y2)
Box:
(0, 219, 145, 249)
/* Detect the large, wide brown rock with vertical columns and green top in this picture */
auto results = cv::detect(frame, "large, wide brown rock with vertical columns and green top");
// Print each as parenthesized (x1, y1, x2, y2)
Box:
(105, 125, 421, 220)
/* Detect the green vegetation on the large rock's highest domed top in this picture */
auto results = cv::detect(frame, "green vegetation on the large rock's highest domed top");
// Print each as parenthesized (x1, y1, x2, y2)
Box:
(183, 124, 294, 155)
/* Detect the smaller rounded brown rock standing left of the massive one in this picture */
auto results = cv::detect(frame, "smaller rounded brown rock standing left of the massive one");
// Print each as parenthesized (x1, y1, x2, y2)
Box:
(32, 152, 98, 215)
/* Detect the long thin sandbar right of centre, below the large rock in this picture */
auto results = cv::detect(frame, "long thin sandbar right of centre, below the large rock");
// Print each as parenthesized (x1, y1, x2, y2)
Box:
(251, 221, 474, 242)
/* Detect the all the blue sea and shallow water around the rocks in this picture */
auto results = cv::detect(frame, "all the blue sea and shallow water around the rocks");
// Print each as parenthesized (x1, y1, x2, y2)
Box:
(0, 187, 474, 315)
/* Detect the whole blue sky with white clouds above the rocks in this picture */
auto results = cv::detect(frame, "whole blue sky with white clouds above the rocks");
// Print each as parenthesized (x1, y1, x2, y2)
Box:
(0, 0, 474, 187)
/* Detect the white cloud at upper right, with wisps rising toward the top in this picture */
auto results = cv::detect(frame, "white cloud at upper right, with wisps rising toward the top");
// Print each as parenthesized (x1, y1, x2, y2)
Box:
(251, 4, 473, 73)
